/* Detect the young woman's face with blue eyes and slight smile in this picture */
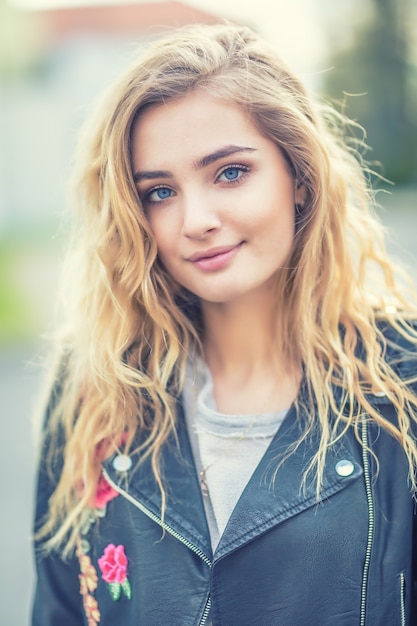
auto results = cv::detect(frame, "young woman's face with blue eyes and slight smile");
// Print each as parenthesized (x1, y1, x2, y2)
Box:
(133, 90, 299, 303)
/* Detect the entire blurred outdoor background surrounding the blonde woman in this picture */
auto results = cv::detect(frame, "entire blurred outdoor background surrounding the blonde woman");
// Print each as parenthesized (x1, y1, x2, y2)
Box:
(0, 0, 417, 626)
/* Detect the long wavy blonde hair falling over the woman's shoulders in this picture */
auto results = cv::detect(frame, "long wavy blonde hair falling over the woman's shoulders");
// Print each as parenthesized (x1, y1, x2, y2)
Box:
(37, 24, 417, 550)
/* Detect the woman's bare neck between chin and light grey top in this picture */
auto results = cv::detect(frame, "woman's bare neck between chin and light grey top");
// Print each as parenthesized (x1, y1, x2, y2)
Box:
(202, 298, 299, 413)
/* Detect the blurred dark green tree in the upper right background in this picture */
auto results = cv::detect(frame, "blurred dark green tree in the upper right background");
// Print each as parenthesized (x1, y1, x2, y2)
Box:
(323, 0, 417, 183)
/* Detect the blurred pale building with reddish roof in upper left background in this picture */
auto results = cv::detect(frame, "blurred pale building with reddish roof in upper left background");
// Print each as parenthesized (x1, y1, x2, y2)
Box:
(0, 2, 219, 232)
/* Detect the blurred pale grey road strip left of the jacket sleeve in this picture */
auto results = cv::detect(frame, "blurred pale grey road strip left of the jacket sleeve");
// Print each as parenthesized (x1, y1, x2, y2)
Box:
(0, 346, 40, 626)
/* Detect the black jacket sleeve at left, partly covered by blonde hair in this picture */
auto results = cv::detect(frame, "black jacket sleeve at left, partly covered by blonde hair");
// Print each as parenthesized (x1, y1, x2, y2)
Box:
(32, 376, 85, 626)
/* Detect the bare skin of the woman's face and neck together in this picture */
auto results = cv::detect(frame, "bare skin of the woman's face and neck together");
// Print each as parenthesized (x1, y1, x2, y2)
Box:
(132, 90, 303, 411)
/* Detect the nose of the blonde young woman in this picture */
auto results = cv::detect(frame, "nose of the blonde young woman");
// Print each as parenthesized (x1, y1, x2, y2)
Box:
(183, 192, 221, 239)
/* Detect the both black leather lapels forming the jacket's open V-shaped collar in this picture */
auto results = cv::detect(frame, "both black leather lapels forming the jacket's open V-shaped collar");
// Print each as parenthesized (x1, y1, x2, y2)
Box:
(103, 392, 362, 560)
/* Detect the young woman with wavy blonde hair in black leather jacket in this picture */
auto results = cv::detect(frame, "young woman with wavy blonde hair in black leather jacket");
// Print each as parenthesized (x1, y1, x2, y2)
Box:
(33, 25, 417, 626)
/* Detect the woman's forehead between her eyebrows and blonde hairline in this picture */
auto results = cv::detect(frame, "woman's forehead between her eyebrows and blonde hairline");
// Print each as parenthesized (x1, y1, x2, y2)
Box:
(132, 91, 269, 168)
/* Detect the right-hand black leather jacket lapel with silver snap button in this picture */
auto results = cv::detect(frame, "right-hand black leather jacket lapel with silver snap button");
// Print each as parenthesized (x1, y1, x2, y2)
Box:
(215, 407, 363, 561)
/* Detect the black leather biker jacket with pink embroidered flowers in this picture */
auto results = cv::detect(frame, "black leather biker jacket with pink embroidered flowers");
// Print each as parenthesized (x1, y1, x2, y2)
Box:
(33, 326, 417, 626)
